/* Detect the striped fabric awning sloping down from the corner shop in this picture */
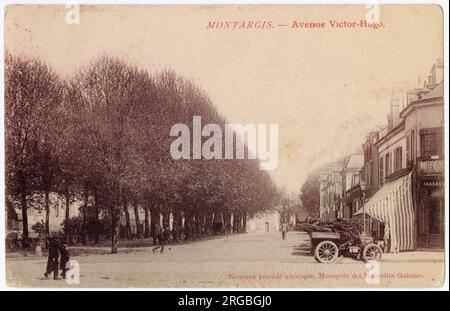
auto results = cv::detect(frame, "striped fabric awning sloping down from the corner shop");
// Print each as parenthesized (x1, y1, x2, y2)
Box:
(354, 173, 415, 252)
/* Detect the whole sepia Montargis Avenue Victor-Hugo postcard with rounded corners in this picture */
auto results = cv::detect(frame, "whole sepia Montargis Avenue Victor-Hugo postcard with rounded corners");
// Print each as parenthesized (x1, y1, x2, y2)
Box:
(2, 2, 448, 290)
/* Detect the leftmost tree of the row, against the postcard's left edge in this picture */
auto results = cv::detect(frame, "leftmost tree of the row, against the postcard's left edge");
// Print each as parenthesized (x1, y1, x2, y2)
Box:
(5, 53, 62, 244)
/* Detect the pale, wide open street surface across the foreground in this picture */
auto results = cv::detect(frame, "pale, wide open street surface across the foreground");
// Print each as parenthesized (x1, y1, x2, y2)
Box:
(6, 232, 444, 288)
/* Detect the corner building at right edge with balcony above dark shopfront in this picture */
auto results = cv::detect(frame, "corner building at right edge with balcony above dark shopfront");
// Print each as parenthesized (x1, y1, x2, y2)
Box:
(401, 78, 445, 248)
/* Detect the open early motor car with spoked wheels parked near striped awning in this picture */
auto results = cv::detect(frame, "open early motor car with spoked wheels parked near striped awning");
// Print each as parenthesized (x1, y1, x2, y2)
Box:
(301, 218, 383, 263)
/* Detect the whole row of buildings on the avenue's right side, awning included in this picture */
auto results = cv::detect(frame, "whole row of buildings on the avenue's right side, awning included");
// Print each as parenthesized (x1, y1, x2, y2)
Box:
(319, 60, 445, 252)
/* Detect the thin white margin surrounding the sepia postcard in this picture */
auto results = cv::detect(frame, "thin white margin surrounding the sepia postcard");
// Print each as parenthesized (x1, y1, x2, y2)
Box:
(0, 0, 449, 291)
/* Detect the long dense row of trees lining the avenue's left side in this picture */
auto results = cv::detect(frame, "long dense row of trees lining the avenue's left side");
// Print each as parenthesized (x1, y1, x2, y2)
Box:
(5, 53, 280, 253)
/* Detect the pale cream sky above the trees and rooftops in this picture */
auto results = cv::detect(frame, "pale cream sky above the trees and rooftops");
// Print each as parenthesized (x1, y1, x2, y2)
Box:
(4, 5, 443, 193)
